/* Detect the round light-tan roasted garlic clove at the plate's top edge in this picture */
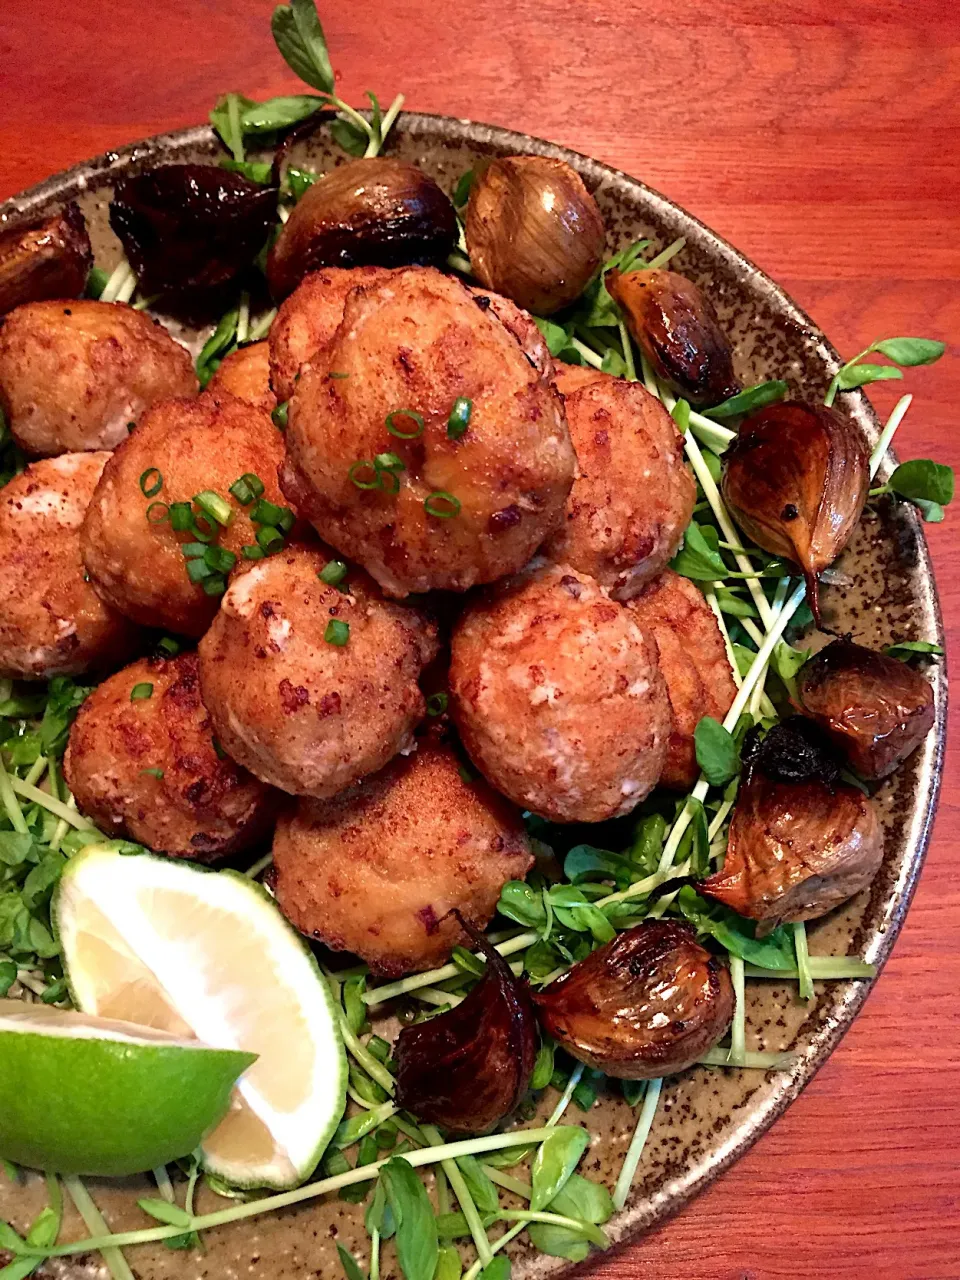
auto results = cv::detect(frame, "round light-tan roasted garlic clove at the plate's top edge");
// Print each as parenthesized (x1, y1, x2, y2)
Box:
(465, 156, 604, 316)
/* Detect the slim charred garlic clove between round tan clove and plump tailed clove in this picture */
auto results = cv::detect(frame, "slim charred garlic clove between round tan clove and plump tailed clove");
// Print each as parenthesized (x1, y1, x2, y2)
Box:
(605, 271, 740, 404)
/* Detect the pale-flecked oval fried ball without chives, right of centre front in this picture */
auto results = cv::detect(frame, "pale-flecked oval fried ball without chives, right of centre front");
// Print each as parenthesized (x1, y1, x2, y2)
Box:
(451, 562, 669, 822)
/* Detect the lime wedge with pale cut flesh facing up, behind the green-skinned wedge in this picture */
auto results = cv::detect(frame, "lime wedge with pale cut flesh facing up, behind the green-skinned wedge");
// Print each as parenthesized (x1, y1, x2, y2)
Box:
(52, 845, 347, 1188)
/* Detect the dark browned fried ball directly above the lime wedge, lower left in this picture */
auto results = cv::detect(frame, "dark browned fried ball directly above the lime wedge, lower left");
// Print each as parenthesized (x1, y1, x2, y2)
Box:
(64, 653, 279, 863)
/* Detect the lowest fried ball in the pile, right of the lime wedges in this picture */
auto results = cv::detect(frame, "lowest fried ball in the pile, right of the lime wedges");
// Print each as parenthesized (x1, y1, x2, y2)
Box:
(274, 733, 534, 977)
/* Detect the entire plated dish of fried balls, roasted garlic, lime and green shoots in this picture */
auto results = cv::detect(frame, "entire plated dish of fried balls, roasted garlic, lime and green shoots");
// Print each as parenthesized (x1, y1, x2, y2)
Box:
(0, 0, 954, 1280)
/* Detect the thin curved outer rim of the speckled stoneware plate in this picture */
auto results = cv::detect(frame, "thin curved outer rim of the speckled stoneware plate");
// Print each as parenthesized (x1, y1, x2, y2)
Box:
(0, 111, 947, 1276)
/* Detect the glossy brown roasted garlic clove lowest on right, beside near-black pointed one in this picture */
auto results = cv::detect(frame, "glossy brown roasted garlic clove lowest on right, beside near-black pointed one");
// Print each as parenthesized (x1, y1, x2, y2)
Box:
(534, 920, 733, 1080)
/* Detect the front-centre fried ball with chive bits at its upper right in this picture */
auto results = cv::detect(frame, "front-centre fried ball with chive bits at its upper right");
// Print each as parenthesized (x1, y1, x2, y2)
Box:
(200, 547, 436, 799)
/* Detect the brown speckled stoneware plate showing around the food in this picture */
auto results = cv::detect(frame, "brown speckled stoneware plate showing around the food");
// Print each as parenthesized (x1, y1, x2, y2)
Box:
(0, 114, 947, 1280)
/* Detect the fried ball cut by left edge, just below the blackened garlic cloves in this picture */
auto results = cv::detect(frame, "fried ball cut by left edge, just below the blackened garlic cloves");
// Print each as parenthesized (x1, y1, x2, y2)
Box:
(0, 298, 197, 457)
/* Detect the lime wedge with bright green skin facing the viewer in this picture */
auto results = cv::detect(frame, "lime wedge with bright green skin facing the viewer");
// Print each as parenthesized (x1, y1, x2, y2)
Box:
(0, 1000, 253, 1178)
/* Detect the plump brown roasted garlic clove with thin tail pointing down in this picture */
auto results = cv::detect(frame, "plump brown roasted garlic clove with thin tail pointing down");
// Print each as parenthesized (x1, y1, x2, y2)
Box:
(722, 404, 870, 626)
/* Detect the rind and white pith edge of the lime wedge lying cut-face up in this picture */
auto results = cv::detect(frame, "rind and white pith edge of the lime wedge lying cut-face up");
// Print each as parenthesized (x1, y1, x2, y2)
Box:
(51, 845, 347, 1190)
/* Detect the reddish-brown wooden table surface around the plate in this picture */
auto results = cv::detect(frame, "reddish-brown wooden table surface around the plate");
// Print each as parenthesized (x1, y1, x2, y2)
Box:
(0, 0, 960, 1280)
